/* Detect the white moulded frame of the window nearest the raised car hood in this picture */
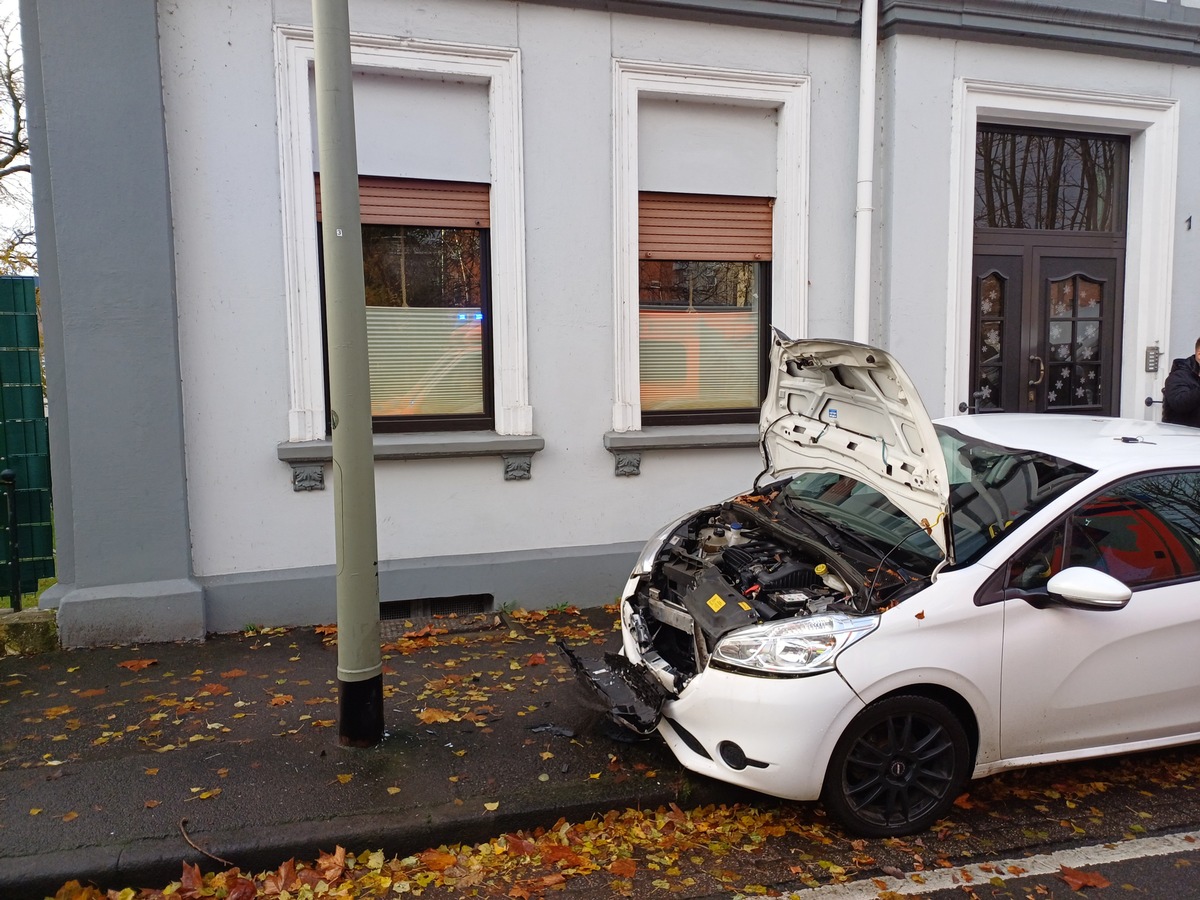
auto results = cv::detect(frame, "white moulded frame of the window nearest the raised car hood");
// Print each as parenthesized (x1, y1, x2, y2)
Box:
(612, 59, 810, 432)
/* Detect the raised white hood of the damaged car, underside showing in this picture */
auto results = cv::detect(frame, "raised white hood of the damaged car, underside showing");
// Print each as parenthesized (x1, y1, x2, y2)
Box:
(758, 331, 953, 562)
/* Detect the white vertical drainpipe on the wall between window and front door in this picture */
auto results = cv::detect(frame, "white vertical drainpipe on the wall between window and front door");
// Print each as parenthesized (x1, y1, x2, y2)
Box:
(854, 0, 880, 343)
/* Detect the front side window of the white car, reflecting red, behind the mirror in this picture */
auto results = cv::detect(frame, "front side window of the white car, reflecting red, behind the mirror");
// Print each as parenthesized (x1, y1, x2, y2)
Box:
(1009, 472, 1200, 590)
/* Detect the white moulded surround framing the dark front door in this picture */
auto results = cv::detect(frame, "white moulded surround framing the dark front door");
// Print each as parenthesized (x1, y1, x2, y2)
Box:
(944, 78, 1180, 419)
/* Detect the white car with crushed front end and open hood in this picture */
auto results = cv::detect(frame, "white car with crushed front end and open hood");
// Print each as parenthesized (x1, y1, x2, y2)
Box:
(568, 335, 1200, 836)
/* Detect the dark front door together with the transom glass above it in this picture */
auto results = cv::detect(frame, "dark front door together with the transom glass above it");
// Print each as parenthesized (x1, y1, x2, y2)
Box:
(959, 125, 1129, 415)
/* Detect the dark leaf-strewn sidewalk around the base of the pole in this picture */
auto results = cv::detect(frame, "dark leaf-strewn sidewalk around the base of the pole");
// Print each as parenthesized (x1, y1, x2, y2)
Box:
(0, 607, 744, 900)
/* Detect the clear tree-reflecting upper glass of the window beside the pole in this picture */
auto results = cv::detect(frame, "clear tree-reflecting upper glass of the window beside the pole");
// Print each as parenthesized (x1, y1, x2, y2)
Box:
(362, 224, 482, 308)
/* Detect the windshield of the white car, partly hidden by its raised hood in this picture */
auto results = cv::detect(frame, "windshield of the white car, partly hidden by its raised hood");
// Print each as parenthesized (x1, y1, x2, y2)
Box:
(782, 425, 1093, 571)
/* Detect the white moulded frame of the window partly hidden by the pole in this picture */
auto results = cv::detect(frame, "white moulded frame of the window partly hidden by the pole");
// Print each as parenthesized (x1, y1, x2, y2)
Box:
(275, 25, 533, 442)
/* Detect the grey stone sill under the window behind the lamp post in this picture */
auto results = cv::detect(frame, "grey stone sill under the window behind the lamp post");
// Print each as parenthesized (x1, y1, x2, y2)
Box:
(276, 431, 546, 491)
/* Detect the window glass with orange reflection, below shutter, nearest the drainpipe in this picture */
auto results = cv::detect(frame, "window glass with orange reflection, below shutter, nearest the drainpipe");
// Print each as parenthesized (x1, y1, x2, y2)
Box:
(638, 259, 768, 413)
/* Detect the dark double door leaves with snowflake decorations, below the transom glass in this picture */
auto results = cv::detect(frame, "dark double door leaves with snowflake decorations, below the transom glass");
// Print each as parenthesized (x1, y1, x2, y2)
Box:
(967, 235, 1124, 415)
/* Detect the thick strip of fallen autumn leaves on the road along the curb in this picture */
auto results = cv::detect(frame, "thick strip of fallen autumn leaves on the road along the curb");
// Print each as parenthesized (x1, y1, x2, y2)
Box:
(46, 758, 1195, 900)
